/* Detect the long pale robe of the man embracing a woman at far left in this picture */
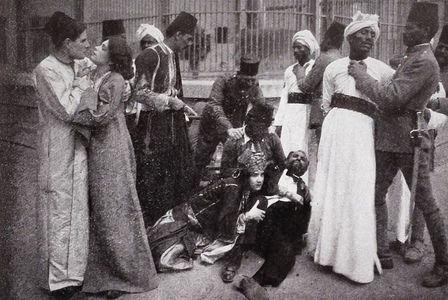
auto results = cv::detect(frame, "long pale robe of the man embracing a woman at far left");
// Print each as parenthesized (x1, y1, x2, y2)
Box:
(33, 55, 89, 290)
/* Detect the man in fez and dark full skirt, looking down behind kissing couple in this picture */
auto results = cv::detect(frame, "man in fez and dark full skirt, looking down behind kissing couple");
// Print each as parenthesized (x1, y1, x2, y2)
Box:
(134, 12, 197, 226)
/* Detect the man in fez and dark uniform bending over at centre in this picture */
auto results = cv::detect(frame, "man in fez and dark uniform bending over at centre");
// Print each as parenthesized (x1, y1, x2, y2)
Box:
(195, 55, 265, 183)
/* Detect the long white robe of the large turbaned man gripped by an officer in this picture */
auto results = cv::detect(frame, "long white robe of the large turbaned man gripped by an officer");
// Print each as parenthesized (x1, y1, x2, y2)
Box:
(309, 57, 393, 283)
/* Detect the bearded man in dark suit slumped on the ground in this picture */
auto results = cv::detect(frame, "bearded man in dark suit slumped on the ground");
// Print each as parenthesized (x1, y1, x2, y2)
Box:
(221, 151, 311, 290)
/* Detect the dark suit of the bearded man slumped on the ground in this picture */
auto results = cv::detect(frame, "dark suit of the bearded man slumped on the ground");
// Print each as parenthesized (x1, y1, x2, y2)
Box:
(227, 178, 311, 286)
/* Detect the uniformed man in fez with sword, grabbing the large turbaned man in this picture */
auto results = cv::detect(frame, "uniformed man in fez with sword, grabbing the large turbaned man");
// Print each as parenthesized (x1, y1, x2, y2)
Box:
(348, 2, 448, 287)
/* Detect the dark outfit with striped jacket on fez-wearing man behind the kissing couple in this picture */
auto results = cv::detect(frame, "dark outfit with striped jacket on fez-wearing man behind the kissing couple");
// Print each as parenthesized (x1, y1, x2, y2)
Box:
(134, 45, 194, 226)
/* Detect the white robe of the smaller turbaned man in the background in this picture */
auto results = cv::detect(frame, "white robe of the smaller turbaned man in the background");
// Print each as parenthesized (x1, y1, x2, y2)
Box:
(274, 59, 314, 183)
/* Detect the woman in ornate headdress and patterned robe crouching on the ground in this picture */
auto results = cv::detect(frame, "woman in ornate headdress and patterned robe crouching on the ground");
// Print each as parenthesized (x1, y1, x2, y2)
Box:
(147, 152, 266, 272)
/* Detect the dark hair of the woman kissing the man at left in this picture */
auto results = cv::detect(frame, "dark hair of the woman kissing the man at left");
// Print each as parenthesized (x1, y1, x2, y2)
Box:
(108, 36, 134, 80)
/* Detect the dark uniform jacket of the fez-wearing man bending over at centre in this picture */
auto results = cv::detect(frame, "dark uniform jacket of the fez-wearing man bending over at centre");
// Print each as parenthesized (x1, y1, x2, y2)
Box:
(201, 75, 265, 137)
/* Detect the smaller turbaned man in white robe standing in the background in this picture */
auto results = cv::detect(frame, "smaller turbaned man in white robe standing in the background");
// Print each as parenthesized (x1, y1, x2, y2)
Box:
(274, 30, 319, 183)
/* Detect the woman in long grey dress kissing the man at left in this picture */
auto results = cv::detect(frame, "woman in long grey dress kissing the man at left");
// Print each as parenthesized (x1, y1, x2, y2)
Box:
(74, 37, 157, 296)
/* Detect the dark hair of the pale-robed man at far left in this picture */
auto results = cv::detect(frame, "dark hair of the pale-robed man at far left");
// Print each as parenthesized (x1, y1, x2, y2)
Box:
(44, 11, 86, 49)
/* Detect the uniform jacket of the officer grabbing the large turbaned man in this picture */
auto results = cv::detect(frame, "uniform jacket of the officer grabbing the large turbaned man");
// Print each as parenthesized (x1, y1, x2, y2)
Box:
(354, 44, 439, 153)
